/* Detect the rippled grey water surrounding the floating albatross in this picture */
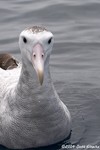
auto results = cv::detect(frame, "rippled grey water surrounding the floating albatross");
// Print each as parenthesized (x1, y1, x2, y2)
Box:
(0, 0, 100, 150)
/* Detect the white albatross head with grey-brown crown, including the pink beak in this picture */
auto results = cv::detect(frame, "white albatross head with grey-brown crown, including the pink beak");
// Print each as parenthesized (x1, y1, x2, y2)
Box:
(19, 26, 54, 85)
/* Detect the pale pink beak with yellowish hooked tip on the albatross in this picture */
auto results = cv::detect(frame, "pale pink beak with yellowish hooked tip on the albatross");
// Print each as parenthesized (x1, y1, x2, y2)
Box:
(32, 43, 44, 85)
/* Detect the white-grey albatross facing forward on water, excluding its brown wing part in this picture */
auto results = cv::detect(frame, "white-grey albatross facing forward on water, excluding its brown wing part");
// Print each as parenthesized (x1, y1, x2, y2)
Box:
(0, 26, 71, 149)
